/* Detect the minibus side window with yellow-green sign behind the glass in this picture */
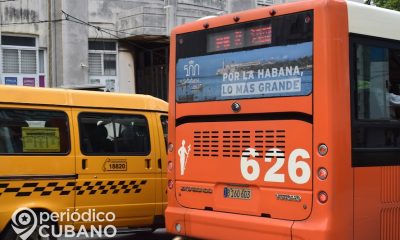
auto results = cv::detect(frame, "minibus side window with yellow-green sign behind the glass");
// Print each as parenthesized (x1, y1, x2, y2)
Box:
(0, 109, 69, 155)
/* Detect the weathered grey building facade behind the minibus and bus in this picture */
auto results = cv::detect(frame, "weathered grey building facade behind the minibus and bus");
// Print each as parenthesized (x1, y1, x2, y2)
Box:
(0, 0, 362, 100)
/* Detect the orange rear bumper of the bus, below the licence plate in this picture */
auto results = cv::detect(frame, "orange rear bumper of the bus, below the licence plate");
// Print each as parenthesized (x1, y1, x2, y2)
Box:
(165, 206, 293, 240)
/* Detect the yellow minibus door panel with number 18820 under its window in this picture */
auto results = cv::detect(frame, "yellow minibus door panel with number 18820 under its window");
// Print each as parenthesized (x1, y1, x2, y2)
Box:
(73, 109, 158, 227)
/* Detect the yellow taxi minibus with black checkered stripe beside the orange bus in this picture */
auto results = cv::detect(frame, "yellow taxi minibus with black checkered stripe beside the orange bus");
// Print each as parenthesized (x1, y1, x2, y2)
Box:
(0, 86, 168, 239)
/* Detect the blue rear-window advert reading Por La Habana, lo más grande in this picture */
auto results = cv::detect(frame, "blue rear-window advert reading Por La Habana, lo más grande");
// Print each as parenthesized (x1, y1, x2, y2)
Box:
(176, 42, 313, 102)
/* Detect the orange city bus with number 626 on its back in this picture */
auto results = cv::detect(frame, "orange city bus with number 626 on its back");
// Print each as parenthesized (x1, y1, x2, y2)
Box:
(166, 0, 400, 240)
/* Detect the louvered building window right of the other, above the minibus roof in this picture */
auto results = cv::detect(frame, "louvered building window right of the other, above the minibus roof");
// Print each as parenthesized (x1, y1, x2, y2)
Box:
(89, 40, 118, 92)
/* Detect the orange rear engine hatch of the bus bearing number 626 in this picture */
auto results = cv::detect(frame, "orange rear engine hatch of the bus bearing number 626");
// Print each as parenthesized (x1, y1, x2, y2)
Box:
(175, 120, 312, 220)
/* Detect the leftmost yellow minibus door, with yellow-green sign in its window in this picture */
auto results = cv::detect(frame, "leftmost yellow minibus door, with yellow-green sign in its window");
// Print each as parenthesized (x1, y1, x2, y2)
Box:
(0, 106, 76, 227)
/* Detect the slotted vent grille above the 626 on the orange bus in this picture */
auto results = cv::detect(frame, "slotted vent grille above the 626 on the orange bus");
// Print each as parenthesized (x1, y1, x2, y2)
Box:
(193, 130, 286, 159)
